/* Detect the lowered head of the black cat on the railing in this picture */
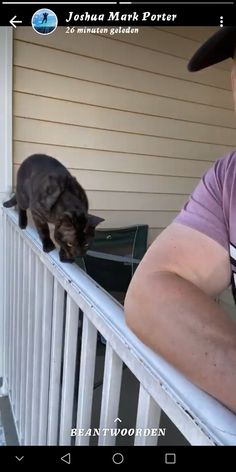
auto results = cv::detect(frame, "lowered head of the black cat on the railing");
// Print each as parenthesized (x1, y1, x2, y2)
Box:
(54, 211, 104, 262)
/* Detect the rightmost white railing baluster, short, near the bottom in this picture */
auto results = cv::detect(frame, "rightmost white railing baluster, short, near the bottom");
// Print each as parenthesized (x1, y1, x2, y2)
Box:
(134, 385, 161, 446)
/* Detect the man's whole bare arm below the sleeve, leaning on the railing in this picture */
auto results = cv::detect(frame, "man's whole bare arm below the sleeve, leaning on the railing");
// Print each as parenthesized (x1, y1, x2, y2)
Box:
(125, 224, 236, 411)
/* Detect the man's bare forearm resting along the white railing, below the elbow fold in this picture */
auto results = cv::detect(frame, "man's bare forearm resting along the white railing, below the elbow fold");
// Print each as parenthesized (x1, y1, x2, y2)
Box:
(125, 272, 236, 411)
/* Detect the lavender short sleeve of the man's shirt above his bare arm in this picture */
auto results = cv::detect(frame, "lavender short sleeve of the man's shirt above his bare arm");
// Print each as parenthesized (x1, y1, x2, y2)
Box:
(174, 157, 229, 250)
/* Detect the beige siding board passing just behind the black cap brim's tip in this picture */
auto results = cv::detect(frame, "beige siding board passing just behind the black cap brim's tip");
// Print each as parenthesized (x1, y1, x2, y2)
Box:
(15, 27, 231, 89)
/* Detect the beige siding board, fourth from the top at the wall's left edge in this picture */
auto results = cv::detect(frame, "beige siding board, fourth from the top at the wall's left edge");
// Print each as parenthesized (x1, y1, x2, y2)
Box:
(14, 92, 236, 146)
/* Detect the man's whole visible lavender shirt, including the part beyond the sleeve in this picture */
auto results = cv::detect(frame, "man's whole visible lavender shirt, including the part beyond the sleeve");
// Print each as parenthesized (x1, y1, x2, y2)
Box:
(174, 151, 236, 294)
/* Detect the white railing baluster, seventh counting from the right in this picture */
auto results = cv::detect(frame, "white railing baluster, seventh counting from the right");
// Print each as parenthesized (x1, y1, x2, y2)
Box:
(30, 257, 44, 445)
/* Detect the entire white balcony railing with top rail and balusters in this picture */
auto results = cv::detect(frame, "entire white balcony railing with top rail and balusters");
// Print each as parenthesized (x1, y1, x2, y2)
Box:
(1, 209, 236, 445)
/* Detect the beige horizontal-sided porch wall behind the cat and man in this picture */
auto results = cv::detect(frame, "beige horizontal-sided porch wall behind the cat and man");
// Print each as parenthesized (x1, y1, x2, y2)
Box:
(14, 27, 236, 314)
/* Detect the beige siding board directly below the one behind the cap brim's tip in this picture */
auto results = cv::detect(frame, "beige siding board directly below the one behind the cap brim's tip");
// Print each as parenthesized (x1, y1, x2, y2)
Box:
(14, 41, 232, 110)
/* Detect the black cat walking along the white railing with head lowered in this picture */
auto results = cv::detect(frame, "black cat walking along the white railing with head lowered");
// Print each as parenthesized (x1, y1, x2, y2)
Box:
(3, 154, 104, 262)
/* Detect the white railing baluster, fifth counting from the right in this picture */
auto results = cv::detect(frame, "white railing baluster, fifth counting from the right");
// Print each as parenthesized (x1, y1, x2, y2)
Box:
(47, 280, 65, 446)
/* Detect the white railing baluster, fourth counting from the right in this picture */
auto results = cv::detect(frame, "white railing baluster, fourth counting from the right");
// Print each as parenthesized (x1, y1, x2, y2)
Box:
(59, 295, 79, 446)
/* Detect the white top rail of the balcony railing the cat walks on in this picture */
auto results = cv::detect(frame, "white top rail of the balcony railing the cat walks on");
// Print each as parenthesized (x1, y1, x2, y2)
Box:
(3, 208, 236, 445)
